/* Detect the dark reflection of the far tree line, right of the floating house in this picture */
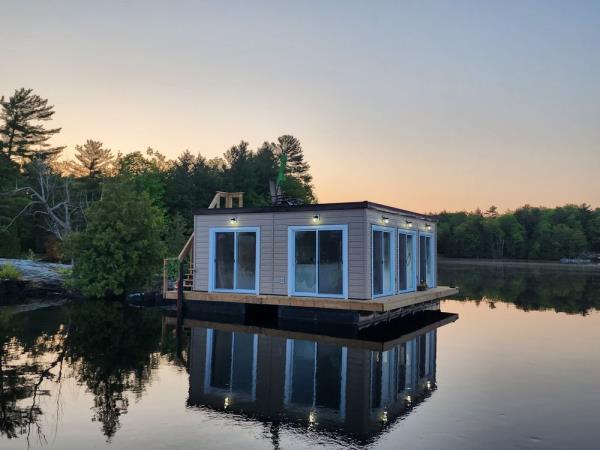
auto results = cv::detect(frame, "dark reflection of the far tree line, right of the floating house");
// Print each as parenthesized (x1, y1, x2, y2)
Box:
(439, 265, 600, 314)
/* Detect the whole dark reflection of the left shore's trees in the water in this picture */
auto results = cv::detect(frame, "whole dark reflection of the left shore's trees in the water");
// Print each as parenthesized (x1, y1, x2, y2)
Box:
(0, 302, 161, 442)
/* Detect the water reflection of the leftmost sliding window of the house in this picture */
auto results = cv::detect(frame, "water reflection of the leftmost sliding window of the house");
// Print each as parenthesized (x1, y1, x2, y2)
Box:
(204, 329, 258, 398)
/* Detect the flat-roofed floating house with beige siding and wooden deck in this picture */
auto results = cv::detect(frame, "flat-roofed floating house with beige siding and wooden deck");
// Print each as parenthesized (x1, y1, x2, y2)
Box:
(164, 201, 457, 328)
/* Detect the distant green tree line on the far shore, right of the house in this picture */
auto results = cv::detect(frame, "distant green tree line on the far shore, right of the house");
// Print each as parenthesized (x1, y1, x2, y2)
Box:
(438, 204, 600, 260)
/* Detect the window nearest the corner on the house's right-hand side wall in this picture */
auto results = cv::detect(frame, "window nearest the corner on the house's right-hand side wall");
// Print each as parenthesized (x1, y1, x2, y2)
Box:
(371, 225, 394, 297)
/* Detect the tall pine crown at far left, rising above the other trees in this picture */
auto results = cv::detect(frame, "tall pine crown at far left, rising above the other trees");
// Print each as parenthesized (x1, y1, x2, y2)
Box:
(0, 88, 64, 165)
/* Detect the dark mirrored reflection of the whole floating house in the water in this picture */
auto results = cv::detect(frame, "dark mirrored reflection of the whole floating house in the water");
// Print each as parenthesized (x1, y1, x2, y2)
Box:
(171, 311, 457, 441)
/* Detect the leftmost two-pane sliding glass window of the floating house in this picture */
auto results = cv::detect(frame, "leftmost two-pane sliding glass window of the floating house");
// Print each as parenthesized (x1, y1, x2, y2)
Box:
(209, 228, 260, 293)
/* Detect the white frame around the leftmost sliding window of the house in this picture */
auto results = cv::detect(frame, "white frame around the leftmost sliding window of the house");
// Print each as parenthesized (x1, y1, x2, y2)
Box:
(208, 227, 260, 294)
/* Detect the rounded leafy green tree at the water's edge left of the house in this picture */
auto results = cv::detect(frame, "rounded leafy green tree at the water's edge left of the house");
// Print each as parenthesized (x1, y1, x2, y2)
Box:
(68, 181, 166, 298)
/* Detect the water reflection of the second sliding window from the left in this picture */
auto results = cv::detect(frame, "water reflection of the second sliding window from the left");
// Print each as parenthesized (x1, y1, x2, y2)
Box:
(285, 339, 347, 413)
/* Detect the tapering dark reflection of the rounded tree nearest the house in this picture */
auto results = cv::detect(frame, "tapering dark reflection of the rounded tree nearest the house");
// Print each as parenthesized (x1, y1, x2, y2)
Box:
(68, 302, 161, 438)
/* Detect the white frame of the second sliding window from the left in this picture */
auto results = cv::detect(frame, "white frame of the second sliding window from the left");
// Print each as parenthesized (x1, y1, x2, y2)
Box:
(288, 225, 348, 299)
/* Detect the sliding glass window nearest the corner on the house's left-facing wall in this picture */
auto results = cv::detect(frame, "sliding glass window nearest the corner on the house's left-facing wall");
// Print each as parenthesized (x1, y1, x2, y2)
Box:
(288, 225, 348, 298)
